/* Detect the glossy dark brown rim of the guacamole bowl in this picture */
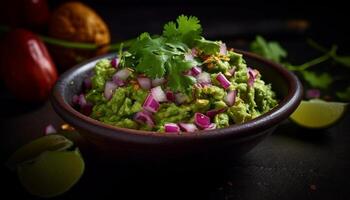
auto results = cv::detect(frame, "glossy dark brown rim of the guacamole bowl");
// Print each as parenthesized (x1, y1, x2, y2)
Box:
(50, 49, 303, 144)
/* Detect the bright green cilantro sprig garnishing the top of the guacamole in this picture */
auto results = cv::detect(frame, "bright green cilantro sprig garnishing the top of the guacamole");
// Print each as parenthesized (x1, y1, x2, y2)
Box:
(120, 15, 221, 93)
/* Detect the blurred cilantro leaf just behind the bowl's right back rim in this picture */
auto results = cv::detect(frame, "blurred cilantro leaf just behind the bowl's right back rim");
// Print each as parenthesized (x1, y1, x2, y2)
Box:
(250, 36, 287, 63)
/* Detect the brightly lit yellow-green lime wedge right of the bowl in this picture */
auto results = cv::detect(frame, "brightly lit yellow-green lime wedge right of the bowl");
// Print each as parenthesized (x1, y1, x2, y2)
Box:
(290, 99, 347, 129)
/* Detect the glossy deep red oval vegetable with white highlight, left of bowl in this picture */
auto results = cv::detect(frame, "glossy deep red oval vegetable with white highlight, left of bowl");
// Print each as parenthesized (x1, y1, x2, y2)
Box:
(1, 29, 57, 102)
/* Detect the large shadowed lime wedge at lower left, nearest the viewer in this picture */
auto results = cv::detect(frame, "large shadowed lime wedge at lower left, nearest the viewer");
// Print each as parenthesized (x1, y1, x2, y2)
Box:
(17, 149, 84, 197)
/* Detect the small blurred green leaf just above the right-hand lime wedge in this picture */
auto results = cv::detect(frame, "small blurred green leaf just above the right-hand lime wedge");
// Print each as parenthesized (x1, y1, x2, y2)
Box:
(301, 70, 333, 89)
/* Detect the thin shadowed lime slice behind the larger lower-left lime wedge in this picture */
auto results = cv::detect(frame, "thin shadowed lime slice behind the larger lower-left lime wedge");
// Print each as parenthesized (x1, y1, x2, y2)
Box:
(6, 134, 73, 169)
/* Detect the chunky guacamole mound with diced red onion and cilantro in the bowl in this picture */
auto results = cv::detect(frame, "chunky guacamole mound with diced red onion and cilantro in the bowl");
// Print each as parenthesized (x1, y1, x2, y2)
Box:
(75, 16, 277, 132)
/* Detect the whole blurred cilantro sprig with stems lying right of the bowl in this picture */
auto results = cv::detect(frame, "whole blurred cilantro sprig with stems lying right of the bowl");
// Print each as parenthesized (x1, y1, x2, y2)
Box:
(250, 36, 350, 101)
